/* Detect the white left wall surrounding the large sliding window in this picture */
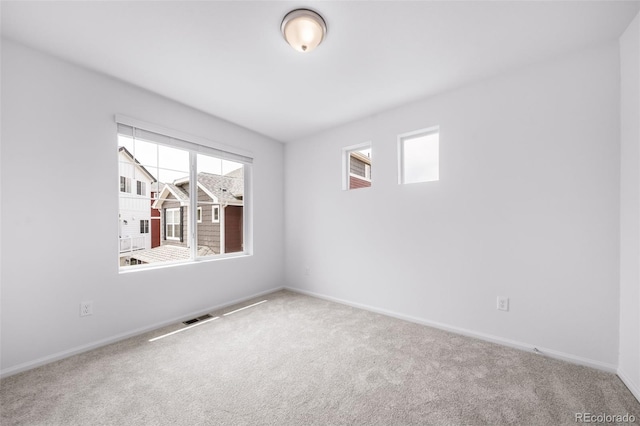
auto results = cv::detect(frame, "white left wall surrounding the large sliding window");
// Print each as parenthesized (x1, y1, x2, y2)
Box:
(1, 41, 284, 374)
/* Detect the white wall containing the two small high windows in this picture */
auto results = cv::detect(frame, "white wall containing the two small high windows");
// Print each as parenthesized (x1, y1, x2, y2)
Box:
(285, 42, 620, 371)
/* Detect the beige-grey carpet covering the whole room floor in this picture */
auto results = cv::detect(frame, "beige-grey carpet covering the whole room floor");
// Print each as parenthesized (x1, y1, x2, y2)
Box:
(0, 291, 640, 426)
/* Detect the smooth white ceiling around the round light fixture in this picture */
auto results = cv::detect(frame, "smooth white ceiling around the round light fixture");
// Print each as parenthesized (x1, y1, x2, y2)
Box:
(1, 1, 640, 142)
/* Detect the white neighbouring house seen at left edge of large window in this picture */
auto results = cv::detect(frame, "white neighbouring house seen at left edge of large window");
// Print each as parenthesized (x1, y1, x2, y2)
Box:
(118, 147, 156, 266)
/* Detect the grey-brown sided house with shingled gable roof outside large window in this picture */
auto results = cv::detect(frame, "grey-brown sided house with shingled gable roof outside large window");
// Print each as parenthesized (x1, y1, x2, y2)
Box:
(130, 168, 244, 264)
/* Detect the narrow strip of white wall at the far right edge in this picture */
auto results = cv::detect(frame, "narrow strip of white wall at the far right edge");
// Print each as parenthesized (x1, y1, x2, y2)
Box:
(618, 15, 640, 400)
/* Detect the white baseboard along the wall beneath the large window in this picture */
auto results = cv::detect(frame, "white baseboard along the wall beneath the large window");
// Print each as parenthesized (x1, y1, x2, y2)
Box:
(0, 287, 284, 378)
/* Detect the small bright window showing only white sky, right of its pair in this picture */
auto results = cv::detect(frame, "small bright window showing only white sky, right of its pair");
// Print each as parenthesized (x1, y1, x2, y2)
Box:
(398, 127, 440, 184)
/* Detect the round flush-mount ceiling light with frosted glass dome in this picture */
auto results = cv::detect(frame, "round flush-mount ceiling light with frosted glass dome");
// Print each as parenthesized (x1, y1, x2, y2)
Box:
(280, 9, 327, 52)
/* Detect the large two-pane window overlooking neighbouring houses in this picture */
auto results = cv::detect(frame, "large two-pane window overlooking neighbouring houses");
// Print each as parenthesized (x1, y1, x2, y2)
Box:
(118, 118, 252, 270)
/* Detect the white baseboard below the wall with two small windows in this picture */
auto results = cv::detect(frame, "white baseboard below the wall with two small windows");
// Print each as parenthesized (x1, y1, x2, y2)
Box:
(285, 287, 618, 374)
